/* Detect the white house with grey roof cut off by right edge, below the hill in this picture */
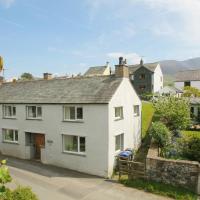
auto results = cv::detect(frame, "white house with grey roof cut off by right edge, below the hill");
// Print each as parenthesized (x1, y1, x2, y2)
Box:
(175, 69, 200, 89)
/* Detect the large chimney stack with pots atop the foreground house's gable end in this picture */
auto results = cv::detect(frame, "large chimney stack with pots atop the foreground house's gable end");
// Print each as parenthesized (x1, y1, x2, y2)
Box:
(115, 57, 129, 78)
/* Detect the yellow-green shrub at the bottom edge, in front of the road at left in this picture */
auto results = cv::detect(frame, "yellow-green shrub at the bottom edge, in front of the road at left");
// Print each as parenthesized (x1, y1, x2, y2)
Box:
(13, 186, 38, 200)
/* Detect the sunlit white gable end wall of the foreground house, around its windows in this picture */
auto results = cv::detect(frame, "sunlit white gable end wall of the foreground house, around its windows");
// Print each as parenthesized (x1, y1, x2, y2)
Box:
(108, 78, 141, 175)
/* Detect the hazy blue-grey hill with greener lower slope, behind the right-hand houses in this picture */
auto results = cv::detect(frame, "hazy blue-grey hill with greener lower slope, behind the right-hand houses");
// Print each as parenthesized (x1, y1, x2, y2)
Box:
(159, 57, 200, 85)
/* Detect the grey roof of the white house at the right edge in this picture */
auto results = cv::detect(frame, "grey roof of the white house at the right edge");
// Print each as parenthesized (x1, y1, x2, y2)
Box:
(175, 69, 200, 82)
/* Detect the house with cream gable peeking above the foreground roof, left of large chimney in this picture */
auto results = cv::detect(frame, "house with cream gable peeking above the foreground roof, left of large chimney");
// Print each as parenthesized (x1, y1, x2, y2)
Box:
(84, 62, 111, 76)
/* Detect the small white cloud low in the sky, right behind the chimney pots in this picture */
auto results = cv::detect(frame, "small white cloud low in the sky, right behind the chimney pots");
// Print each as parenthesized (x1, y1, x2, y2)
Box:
(107, 52, 141, 64)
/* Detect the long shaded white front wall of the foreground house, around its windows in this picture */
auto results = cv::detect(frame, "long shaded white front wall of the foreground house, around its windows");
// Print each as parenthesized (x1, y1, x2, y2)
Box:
(0, 104, 108, 176)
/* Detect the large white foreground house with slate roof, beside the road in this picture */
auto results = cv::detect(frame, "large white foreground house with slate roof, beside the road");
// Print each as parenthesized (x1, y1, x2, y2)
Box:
(0, 57, 141, 177)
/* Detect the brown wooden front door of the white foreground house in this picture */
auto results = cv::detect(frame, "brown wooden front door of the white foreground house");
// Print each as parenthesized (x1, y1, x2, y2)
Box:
(35, 134, 45, 159)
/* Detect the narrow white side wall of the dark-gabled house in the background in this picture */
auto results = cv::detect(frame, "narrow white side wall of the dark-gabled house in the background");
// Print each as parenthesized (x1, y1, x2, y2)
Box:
(152, 64, 163, 93)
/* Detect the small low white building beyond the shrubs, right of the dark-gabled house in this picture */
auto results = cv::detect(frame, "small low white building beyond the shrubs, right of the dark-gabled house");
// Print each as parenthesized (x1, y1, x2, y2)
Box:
(158, 86, 183, 97)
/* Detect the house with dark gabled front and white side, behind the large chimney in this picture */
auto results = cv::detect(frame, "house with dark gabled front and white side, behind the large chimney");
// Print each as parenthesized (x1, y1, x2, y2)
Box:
(129, 59, 163, 95)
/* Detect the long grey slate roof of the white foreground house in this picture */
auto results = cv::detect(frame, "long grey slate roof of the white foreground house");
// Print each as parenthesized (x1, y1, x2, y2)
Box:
(0, 76, 122, 104)
